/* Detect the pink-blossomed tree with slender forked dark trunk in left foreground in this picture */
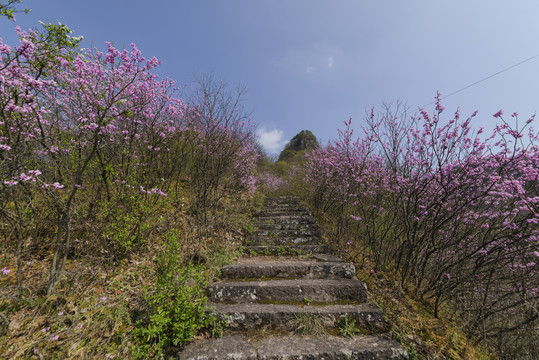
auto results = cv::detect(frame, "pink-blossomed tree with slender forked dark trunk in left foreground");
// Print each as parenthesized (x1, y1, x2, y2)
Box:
(0, 30, 182, 293)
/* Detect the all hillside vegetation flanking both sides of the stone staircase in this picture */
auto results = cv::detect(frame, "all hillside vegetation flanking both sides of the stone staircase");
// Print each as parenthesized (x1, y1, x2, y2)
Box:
(0, 11, 539, 359)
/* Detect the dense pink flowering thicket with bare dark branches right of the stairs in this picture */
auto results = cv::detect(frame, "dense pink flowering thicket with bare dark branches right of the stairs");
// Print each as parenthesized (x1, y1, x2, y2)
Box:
(307, 98, 539, 358)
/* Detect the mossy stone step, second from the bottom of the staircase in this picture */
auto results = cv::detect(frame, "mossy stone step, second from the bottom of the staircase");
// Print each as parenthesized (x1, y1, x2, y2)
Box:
(208, 303, 384, 333)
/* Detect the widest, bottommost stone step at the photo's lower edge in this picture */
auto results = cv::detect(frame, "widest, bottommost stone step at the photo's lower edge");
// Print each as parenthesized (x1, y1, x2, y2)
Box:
(179, 335, 408, 360)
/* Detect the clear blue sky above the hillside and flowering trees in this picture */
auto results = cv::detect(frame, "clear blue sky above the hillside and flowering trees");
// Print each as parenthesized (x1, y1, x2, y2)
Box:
(0, 0, 539, 153)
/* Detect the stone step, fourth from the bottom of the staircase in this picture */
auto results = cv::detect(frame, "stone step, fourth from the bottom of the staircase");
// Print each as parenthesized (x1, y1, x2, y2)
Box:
(221, 257, 356, 279)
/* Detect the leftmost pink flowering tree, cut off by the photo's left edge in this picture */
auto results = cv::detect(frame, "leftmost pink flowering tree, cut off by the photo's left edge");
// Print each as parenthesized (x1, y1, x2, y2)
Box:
(0, 24, 80, 286)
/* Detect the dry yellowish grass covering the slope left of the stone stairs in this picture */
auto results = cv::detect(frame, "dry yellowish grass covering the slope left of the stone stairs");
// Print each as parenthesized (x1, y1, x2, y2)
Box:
(0, 190, 258, 359)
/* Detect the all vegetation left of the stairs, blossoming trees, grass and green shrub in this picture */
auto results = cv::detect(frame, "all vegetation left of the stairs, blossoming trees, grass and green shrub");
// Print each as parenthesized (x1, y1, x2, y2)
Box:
(0, 24, 258, 359)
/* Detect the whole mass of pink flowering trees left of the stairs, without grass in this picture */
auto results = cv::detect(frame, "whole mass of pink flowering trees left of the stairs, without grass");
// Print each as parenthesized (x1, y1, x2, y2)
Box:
(0, 25, 258, 293)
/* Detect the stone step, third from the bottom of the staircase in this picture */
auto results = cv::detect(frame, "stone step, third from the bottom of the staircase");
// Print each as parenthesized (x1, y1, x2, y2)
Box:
(208, 279, 367, 303)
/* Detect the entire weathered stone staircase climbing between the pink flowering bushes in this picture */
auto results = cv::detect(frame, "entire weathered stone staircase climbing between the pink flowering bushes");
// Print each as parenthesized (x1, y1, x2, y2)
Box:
(179, 197, 408, 360)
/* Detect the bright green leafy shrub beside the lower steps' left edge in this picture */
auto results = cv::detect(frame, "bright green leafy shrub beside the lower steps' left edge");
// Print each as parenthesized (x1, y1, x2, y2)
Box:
(133, 230, 223, 358)
